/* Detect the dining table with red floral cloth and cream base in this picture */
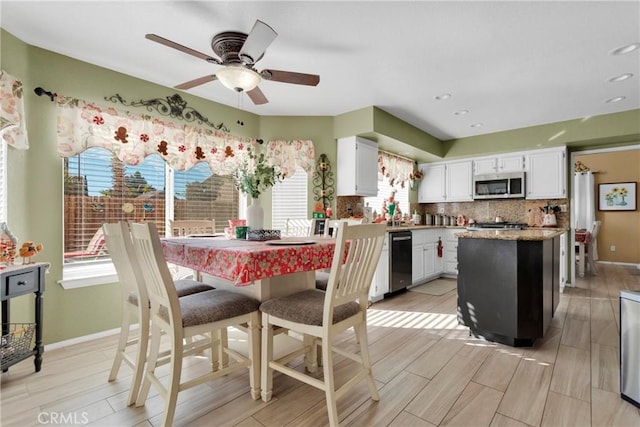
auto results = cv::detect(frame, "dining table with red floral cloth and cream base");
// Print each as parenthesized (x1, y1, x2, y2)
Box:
(161, 235, 335, 301)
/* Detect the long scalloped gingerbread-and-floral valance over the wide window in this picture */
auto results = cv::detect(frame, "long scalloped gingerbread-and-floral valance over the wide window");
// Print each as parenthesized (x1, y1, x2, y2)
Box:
(57, 96, 257, 175)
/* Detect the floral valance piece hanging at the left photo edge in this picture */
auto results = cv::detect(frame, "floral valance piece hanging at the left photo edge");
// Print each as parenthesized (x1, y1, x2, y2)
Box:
(0, 70, 29, 150)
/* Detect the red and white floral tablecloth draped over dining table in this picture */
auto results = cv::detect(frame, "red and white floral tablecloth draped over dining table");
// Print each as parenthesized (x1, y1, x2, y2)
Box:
(162, 238, 335, 286)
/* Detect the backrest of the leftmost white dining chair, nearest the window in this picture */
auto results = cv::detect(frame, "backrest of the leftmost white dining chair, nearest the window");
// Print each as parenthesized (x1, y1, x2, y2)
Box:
(102, 222, 148, 307)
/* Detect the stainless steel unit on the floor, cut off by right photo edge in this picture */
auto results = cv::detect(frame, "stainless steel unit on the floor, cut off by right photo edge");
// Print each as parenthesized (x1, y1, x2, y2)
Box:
(620, 291, 640, 407)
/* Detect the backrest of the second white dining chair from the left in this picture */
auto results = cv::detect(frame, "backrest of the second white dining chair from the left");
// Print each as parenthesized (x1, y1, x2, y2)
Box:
(129, 222, 182, 329)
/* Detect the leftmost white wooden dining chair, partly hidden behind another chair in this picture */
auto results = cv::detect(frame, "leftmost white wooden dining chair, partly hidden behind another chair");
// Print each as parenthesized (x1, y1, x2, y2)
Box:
(102, 222, 213, 405)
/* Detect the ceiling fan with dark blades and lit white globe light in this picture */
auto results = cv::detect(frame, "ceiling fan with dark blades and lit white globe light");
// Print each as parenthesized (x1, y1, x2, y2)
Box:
(145, 20, 320, 105)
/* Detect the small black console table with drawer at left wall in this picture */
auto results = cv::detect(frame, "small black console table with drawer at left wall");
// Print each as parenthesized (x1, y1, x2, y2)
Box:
(0, 262, 49, 372)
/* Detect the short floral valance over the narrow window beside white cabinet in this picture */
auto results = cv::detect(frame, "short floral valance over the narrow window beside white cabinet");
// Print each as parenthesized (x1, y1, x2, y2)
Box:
(267, 140, 316, 177)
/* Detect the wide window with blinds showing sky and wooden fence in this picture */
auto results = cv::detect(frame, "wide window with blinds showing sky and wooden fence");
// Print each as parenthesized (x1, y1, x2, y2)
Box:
(63, 148, 238, 264)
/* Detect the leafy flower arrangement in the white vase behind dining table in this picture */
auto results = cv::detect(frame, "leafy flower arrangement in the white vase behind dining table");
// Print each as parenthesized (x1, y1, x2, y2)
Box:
(236, 147, 284, 199)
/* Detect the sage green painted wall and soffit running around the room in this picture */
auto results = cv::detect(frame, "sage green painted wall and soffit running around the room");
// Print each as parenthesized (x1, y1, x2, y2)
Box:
(0, 30, 640, 344)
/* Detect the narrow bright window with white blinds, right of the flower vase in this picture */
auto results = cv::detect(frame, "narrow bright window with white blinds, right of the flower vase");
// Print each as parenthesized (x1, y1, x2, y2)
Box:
(271, 166, 309, 234)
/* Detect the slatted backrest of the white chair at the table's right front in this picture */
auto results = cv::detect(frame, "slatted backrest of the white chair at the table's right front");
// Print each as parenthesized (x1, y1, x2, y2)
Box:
(323, 221, 387, 325)
